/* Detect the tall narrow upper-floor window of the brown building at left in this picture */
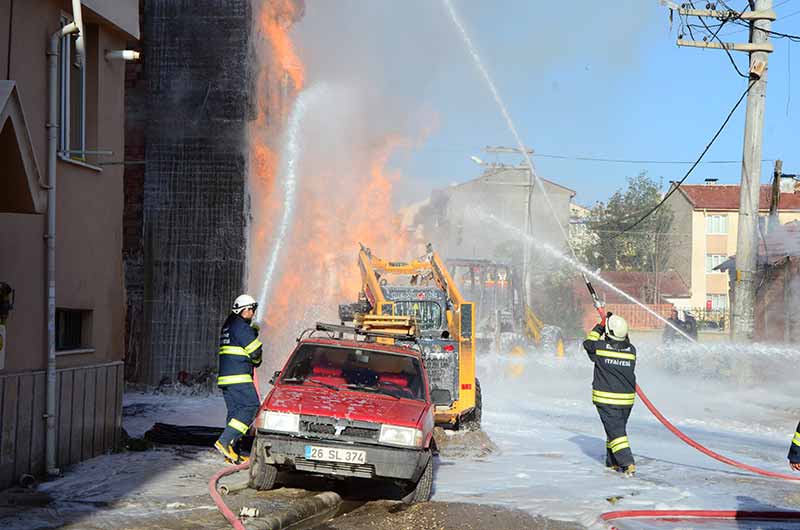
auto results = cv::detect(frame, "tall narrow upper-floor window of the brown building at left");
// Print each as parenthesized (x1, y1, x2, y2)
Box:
(59, 13, 88, 160)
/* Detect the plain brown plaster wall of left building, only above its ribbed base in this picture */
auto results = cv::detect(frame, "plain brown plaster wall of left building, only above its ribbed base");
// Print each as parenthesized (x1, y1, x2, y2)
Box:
(0, 0, 125, 373)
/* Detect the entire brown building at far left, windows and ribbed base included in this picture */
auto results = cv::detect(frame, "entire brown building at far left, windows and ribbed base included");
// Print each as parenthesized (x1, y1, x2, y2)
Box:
(0, 0, 139, 488)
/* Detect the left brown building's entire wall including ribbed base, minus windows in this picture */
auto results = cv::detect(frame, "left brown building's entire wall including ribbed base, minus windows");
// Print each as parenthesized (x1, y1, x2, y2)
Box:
(0, 0, 127, 488)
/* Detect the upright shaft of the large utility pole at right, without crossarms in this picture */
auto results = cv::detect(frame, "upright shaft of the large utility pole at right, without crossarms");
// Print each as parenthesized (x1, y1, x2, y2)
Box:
(731, 0, 774, 341)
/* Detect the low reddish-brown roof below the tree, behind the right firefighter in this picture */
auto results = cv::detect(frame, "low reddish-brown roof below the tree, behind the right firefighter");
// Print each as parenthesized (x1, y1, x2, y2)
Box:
(594, 271, 691, 304)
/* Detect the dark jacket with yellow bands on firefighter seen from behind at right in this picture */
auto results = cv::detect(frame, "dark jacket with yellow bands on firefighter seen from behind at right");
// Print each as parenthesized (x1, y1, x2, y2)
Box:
(583, 324, 636, 407)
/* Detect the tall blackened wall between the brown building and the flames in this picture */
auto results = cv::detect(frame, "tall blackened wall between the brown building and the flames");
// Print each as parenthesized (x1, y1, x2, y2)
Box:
(131, 0, 252, 384)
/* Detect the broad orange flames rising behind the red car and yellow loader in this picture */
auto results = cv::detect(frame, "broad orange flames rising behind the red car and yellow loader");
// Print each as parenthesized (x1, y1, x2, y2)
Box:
(264, 137, 410, 361)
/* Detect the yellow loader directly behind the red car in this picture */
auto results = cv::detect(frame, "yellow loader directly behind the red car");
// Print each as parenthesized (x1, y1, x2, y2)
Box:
(339, 244, 482, 428)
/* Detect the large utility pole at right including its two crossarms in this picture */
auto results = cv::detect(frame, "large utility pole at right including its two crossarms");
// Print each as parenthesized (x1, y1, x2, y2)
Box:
(667, 0, 776, 341)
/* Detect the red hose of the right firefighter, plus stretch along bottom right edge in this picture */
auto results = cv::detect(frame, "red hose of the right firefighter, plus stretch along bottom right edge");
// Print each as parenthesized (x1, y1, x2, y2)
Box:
(584, 275, 800, 521)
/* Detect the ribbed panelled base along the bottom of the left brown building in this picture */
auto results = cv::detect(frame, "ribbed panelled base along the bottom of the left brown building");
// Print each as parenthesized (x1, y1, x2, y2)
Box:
(0, 361, 124, 490)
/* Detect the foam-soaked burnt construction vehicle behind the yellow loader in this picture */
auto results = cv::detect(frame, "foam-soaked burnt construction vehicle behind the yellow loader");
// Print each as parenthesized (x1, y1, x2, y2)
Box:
(447, 259, 564, 357)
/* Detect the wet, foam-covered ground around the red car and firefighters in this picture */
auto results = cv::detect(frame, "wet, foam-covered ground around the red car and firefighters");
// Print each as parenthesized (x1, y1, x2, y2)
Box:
(0, 338, 800, 530)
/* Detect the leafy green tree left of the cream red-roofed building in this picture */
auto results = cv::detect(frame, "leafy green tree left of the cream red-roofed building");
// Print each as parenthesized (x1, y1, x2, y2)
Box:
(575, 172, 673, 294)
